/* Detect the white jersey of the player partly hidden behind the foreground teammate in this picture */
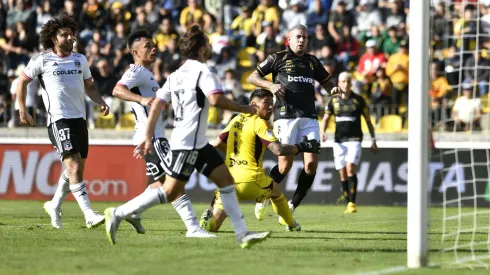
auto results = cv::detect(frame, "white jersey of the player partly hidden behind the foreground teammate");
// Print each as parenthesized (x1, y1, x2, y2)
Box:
(117, 64, 165, 145)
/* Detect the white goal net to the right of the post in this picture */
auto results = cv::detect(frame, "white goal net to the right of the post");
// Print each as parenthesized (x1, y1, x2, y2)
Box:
(429, 0, 490, 269)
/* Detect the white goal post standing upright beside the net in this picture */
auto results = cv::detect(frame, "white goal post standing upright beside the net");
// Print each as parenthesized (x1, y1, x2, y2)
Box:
(407, 0, 430, 268)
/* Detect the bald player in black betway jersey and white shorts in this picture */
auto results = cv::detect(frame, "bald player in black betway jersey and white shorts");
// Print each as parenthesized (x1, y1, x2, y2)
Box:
(247, 25, 339, 223)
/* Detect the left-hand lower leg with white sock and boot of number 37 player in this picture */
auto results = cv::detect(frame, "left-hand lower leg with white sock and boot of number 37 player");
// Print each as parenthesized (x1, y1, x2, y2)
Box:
(44, 171, 70, 229)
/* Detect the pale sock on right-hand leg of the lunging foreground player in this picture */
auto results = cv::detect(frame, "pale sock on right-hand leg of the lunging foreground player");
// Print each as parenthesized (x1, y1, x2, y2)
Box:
(219, 185, 248, 237)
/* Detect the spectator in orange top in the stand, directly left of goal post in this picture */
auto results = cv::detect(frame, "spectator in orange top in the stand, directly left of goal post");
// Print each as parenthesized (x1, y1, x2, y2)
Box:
(386, 40, 408, 106)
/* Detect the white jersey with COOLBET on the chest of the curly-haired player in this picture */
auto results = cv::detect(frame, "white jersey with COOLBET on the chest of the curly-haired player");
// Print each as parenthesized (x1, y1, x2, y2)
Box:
(22, 51, 93, 126)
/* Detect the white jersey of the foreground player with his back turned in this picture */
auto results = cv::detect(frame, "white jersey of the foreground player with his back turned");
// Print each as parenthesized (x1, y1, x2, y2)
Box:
(157, 59, 223, 150)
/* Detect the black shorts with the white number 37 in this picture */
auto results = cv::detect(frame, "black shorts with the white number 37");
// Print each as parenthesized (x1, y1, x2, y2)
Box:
(48, 118, 88, 160)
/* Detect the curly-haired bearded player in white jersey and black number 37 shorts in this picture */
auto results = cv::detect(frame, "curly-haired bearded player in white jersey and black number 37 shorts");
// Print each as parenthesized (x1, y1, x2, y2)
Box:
(17, 16, 109, 229)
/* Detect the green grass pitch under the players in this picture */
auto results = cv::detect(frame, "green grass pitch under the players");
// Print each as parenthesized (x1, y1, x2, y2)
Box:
(0, 201, 489, 275)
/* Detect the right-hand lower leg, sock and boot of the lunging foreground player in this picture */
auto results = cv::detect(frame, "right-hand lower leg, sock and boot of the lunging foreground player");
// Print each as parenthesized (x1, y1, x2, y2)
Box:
(209, 164, 270, 248)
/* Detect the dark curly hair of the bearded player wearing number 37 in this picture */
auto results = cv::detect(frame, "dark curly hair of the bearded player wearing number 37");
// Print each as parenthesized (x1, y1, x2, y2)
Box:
(39, 15, 78, 50)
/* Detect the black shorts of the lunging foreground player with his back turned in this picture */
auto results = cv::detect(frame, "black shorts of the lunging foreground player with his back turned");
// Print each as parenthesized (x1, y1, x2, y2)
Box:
(167, 144, 224, 181)
